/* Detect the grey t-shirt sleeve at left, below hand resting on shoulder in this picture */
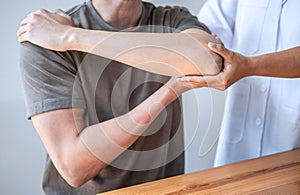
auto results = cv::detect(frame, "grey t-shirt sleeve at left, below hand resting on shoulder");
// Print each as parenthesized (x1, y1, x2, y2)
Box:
(20, 43, 85, 119)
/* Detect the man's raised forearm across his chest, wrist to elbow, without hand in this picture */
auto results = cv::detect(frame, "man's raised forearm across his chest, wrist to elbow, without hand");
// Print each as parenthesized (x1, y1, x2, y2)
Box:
(68, 28, 221, 76)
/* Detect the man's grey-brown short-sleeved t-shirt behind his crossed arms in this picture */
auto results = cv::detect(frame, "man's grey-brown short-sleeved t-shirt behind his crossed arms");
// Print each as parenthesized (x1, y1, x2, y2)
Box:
(20, 0, 203, 195)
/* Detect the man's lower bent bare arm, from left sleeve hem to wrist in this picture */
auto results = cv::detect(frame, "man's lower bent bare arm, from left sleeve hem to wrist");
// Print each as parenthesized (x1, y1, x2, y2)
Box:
(32, 74, 194, 187)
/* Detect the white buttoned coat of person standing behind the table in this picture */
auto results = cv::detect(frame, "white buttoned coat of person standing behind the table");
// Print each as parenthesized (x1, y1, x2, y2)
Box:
(198, 0, 300, 166)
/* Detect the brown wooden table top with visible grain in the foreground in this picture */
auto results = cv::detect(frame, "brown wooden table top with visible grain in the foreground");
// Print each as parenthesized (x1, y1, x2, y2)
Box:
(103, 149, 300, 195)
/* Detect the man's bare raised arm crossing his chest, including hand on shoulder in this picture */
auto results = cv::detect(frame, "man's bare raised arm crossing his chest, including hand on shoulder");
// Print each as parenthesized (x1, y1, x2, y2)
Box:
(18, 10, 222, 76)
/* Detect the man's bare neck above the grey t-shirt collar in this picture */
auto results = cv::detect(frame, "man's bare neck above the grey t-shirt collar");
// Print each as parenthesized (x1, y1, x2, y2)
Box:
(92, 0, 142, 29)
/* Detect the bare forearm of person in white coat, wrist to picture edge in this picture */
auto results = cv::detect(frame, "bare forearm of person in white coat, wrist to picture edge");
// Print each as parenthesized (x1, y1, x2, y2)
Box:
(249, 46, 300, 78)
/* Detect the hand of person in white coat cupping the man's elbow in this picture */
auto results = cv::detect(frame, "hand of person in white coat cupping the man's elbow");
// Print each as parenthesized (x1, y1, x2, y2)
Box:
(186, 43, 252, 91)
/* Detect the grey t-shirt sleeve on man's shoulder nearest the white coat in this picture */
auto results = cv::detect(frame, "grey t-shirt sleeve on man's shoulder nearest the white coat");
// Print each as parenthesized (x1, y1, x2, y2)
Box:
(172, 8, 207, 32)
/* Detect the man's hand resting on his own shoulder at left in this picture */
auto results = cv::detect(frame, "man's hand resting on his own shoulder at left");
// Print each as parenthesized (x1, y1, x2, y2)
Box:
(17, 9, 74, 51)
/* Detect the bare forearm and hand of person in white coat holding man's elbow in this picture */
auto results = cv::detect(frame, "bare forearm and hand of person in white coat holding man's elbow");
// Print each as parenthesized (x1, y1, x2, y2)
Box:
(190, 43, 300, 90)
